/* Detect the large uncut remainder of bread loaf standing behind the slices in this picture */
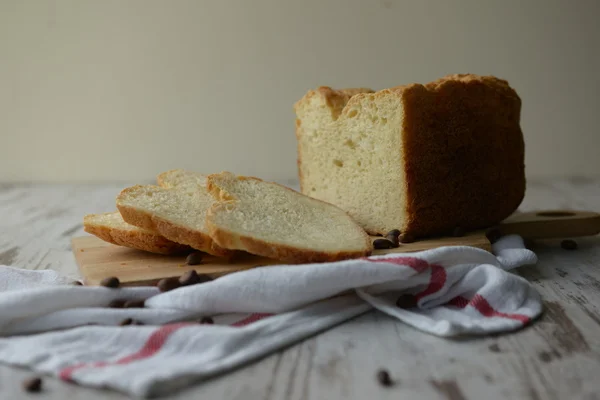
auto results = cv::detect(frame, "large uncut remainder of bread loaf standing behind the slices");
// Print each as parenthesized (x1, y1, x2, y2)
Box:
(294, 74, 525, 238)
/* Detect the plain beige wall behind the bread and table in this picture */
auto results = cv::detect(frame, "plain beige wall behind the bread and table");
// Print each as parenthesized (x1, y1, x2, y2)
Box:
(0, 0, 600, 181)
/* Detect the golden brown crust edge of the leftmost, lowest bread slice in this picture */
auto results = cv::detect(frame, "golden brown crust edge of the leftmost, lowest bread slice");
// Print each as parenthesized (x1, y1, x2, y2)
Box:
(83, 217, 191, 255)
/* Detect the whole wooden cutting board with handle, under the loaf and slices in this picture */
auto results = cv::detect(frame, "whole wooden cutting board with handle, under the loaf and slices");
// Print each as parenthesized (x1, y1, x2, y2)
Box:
(71, 210, 600, 286)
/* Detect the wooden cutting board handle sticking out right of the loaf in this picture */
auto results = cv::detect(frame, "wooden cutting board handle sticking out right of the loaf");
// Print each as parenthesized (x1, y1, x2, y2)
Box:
(499, 210, 600, 239)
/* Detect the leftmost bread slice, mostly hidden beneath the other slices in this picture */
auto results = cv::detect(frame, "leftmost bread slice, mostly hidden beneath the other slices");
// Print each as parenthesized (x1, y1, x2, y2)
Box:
(83, 212, 191, 254)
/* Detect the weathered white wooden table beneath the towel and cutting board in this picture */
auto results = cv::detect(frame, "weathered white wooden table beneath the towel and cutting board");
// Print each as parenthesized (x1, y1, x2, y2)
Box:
(0, 179, 600, 400)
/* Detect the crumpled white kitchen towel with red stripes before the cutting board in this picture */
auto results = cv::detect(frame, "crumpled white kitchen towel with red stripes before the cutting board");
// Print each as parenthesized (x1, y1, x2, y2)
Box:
(0, 235, 542, 397)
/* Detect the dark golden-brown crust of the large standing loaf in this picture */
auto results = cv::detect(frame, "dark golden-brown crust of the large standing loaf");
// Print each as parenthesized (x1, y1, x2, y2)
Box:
(295, 74, 526, 237)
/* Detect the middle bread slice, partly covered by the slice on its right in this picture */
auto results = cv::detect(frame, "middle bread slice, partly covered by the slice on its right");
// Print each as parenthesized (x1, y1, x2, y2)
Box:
(117, 185, 235, 257)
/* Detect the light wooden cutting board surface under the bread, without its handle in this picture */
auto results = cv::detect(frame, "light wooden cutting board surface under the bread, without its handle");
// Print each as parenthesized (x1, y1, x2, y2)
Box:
(71, 232, 491, 286)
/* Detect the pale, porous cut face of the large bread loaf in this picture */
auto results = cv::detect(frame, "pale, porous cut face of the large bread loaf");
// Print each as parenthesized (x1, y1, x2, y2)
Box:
(295, 92, 406, 234)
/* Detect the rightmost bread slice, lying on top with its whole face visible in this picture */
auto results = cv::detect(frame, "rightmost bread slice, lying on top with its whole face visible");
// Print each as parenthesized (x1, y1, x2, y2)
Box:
(206, 172, 372, 263)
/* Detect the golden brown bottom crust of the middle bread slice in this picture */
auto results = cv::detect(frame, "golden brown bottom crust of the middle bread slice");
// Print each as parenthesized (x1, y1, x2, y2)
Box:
(117, 204, 237, 258)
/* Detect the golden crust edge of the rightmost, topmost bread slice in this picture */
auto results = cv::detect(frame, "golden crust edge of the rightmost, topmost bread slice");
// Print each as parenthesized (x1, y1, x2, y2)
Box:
(206, 173, 372, 264)
